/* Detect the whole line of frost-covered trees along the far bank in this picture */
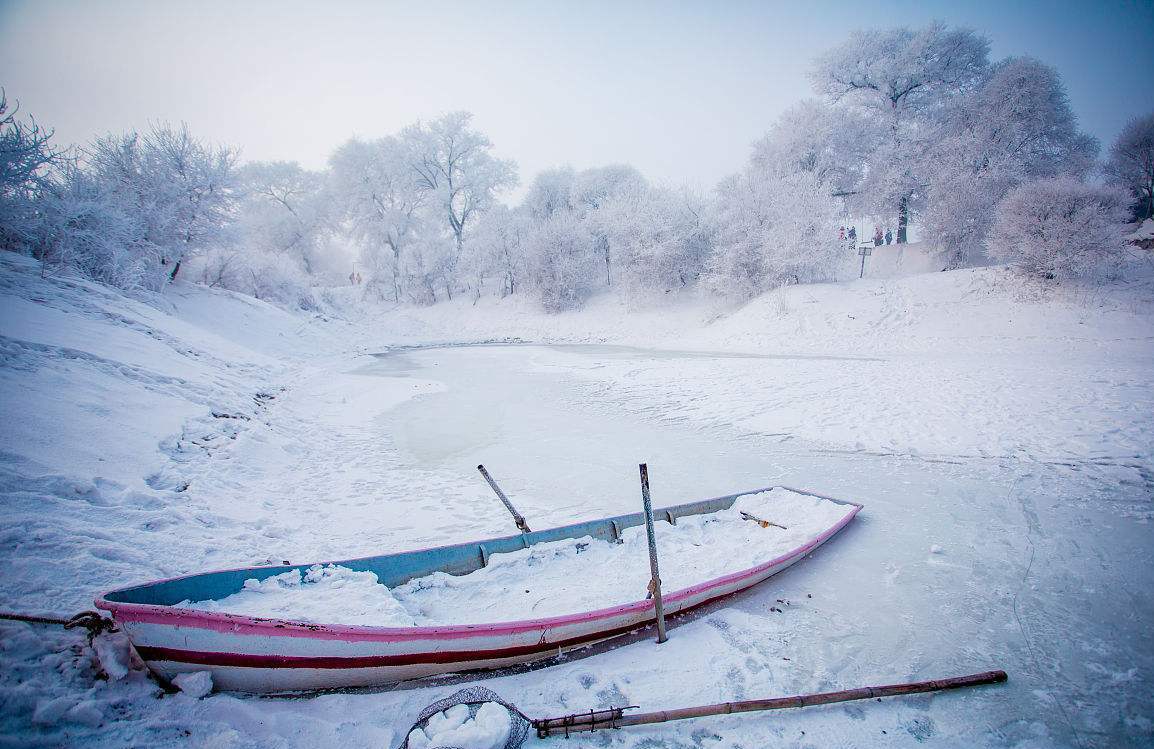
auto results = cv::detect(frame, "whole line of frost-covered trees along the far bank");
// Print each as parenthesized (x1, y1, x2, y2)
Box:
(0, 24, 1154, 312)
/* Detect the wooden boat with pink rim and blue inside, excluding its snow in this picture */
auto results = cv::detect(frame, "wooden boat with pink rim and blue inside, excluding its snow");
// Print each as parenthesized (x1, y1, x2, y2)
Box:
(96, 487, 862, 694)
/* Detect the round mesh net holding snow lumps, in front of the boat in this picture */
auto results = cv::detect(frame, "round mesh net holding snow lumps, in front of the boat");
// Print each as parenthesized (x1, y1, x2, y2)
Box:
(397, 687, 531, 749)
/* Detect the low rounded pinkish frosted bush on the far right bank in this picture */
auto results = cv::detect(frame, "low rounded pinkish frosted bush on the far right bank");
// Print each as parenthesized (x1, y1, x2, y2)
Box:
(986, 177, 1126, 279)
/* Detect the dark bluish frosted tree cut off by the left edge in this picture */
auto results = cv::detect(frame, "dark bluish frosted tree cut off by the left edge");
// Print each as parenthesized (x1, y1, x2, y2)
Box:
(0, 89, 62, 253)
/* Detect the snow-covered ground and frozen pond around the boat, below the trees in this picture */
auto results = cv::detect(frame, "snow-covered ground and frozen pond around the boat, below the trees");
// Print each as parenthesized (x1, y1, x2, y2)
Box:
(0, 248, 1154, 747)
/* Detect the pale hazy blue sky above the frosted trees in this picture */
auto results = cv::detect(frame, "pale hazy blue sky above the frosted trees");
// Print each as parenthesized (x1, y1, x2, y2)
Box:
(0, 0, 1154, 197)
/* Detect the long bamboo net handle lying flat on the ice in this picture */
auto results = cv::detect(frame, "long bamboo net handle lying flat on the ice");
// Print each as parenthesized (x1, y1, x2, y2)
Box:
(533, 671, 1006, 739)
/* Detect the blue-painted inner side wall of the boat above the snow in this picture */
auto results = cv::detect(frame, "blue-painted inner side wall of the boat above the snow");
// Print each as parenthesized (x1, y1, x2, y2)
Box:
(105, 487, 853, 606)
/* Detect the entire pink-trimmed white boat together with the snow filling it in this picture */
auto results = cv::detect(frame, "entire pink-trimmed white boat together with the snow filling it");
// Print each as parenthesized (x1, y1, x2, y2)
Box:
(96, 487, 862, 692)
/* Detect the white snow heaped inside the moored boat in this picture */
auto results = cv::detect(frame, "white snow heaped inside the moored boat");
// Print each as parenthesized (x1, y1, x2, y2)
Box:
(179, 488, 852, 627)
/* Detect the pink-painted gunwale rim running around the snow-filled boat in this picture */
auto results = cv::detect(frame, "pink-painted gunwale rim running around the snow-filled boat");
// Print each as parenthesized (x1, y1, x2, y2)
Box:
(95, 485, 864, 642)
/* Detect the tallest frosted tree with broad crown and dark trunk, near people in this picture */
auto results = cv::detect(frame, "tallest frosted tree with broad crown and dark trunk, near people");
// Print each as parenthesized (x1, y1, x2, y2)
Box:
(812, 23, 989, 242)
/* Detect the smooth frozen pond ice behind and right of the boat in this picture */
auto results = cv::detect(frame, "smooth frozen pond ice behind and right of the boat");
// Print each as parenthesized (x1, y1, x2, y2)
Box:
(343, 345, 1154, 746)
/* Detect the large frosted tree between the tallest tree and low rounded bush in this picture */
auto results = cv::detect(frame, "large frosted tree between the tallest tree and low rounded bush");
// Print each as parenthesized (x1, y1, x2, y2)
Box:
(924, 58, 1097, 267)
